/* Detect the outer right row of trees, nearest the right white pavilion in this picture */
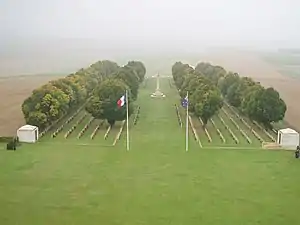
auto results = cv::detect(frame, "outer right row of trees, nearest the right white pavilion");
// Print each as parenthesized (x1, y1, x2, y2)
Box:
(218, 73, 287, 129)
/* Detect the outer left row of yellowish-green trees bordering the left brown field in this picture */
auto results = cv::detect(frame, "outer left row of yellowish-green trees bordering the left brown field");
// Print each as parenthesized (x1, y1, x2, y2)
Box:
(22, 60, 146, 129)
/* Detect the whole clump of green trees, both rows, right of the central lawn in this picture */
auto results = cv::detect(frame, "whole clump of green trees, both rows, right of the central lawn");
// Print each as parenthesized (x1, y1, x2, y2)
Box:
(172, 62, 287, 128)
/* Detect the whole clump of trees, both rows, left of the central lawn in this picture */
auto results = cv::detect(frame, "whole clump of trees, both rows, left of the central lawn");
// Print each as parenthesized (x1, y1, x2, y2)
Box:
(22, 60, 146, 129)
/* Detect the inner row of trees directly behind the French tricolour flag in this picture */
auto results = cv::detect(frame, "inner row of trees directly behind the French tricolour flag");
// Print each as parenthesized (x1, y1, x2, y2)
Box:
(86, 61, 146, 126)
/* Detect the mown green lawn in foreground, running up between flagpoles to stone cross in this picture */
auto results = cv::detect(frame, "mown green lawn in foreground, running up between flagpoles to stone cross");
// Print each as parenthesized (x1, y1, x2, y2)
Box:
(0, 80, 300, 225)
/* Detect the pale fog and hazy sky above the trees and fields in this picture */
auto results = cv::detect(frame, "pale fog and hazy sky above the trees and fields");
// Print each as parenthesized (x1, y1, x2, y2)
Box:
(0, 0, 300, 76)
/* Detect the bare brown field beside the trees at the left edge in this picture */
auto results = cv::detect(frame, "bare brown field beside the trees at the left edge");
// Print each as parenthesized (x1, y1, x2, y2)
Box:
(0, 75, 63, 136)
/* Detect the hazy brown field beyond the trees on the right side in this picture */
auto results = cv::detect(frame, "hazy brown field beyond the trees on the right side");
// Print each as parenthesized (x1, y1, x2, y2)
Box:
(201, 51, 300, 130)
